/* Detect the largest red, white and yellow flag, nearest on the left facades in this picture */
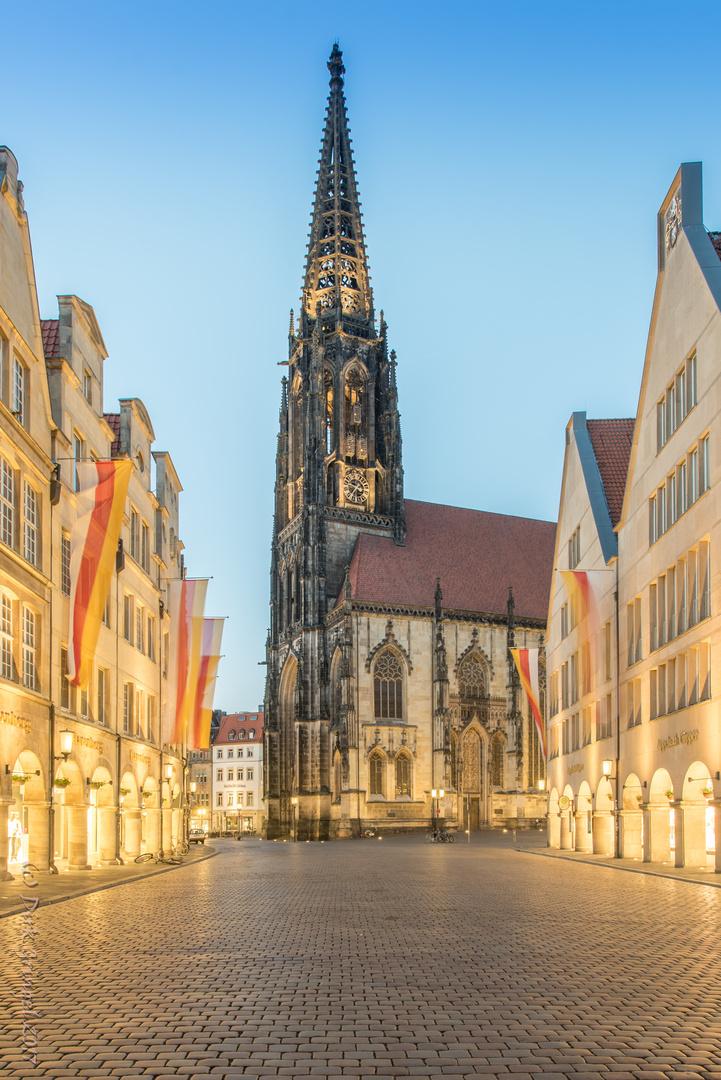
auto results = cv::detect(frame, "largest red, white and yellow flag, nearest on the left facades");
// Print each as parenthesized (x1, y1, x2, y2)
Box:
(68, 460, 133, 688)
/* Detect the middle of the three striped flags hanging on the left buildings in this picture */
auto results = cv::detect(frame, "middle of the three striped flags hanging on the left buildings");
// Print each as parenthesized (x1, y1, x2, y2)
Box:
(166, 578, 208, 744)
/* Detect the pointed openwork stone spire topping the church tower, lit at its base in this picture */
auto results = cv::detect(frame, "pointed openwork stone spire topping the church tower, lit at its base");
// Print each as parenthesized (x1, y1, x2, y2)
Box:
(302, 44, 373, 333)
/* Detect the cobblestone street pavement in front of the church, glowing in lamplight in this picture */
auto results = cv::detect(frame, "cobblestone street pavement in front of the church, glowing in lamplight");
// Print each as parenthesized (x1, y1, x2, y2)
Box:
(0, 838, 721, 1080)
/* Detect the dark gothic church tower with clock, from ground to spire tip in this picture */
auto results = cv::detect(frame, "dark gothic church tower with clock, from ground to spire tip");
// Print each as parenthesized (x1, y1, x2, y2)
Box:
(266, 44, 405, 839)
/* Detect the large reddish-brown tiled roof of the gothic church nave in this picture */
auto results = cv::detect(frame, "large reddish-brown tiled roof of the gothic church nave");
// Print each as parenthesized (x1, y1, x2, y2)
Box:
(339, 500, 556, 620)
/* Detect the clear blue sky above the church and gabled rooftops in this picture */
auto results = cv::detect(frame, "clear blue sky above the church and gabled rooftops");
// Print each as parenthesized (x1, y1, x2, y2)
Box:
(8, 0, 721, 712)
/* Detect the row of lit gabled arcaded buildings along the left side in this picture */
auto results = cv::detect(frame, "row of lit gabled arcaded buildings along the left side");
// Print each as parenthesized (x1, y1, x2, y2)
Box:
(0, 148, 191, 876)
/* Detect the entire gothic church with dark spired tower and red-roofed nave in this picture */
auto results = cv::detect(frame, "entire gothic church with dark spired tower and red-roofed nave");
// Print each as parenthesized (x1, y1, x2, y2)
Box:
(264, 45, 556, 839)
